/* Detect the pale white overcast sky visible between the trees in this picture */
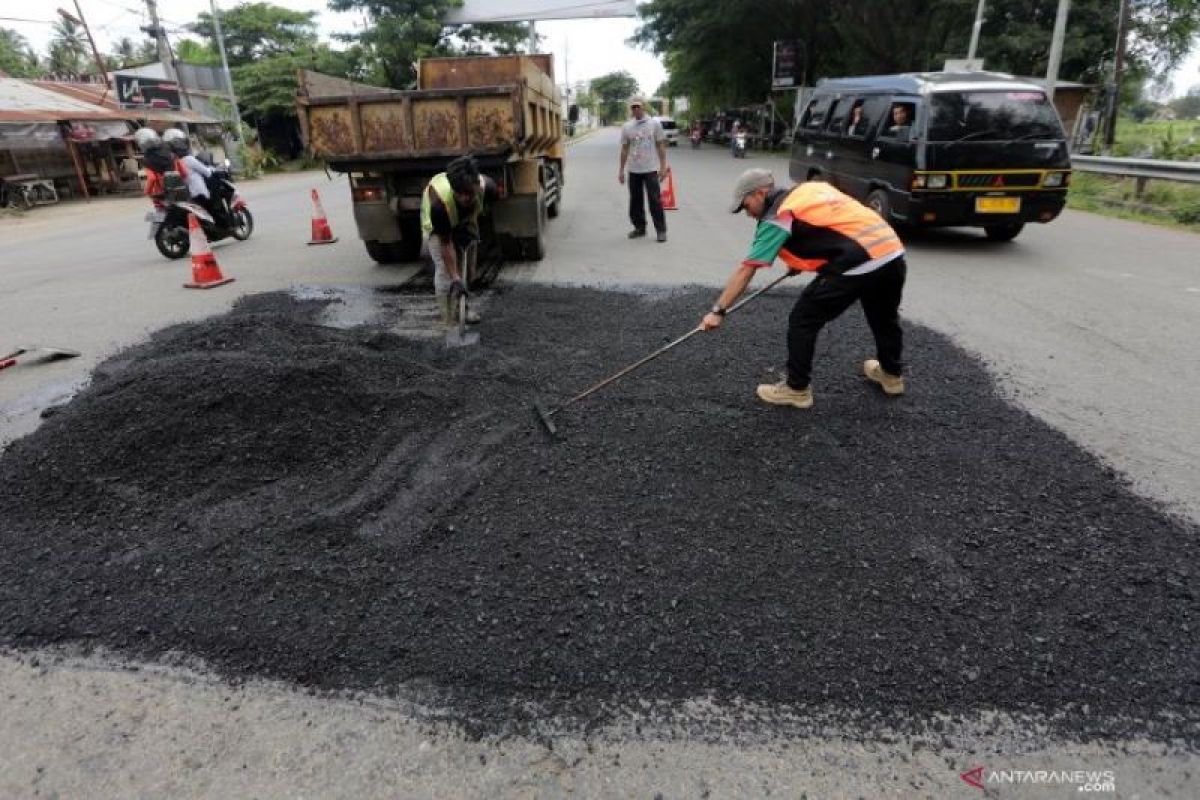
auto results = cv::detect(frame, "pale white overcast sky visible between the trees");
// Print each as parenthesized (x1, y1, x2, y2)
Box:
(9, 0, 1200, 95)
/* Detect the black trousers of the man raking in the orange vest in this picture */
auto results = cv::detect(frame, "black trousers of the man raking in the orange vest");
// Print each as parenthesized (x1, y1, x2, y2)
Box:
(787, 255, 908, 389)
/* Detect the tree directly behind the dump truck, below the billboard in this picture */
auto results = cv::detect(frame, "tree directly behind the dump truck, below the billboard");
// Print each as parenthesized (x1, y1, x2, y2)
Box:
(329, 0, 529, 89)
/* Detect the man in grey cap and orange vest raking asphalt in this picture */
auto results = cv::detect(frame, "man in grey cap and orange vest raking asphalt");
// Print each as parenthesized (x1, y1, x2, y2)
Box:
(701, 169, 907, 408)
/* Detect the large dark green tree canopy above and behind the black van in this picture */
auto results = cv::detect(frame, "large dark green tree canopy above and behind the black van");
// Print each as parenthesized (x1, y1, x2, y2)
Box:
(634, 0, 1200, 109)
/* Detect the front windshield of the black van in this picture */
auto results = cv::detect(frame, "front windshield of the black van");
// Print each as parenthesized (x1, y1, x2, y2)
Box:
(929, 91, 1063, 142)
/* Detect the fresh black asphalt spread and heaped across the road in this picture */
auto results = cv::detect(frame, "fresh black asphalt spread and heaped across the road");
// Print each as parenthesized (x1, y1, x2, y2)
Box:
(0, 288, 1200, 741)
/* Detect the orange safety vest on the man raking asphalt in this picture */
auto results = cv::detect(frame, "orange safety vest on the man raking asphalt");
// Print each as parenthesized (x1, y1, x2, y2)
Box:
(772, 181, 904, 275)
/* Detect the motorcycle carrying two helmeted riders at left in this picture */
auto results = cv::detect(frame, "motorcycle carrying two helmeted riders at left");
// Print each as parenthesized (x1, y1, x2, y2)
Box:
(145, 169, 254, 259)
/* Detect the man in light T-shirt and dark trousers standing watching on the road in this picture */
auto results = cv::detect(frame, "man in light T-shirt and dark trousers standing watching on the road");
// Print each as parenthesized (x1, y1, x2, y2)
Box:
(617, 97, 667, 242)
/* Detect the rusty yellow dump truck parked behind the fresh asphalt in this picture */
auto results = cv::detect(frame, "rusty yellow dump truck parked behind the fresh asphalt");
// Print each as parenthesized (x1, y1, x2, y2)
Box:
(296, 54, 564, 271)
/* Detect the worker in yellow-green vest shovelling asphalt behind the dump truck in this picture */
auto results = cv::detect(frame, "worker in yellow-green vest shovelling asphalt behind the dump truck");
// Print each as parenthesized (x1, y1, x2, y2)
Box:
(421, 156, 498, 326)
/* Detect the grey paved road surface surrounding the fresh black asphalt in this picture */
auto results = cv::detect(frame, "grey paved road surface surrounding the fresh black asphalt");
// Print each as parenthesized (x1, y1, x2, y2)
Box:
(0, 131, 1200, 798)
